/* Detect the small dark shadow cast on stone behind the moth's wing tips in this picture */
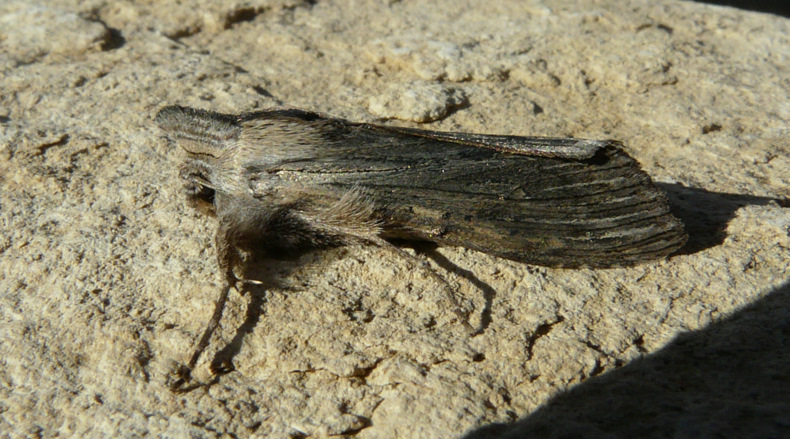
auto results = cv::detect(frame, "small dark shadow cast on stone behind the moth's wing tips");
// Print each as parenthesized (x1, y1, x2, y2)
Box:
(656, 183, 790, 254)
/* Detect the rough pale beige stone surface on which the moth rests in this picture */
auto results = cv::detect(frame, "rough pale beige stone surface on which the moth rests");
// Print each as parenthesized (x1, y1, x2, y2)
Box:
(0, 0, 790, 438)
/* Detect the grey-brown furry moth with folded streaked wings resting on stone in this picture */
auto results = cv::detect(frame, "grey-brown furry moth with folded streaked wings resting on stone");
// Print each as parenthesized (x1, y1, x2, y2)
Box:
(156, 106, 686, 388)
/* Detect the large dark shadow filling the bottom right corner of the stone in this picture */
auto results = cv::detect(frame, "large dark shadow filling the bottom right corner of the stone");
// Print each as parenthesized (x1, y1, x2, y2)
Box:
(463, 280, 790, 439)
